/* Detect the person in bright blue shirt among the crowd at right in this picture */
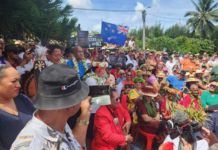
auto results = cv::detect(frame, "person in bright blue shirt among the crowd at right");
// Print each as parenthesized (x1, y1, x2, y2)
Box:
(166, 70, 187, 91)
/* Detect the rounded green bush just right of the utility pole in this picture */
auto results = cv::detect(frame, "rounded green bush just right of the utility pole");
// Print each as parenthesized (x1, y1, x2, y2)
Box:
(146, 36, 177, 53)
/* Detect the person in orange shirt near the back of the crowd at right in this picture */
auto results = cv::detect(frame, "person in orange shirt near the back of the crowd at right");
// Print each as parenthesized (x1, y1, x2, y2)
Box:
(181, 54, 199, 72)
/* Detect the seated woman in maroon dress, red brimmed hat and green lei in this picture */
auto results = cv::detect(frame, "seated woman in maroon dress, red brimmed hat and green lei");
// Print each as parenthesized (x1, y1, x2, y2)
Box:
(136, 85, 167, 143)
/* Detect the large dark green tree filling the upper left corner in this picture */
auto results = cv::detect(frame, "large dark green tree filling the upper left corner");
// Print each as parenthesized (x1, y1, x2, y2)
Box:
(0, 0, 77, 43)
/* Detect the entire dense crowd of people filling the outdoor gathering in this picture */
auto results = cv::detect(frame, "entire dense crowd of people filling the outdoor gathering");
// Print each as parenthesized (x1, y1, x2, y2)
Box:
(0, 37, 218, 150)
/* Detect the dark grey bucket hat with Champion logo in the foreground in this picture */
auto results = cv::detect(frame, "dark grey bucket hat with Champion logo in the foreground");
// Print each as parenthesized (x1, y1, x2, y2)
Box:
(33, 64, 89, 110)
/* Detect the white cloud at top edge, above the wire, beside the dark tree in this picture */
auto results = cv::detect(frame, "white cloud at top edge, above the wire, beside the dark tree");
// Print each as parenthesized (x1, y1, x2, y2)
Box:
(68, 0, 92, 9)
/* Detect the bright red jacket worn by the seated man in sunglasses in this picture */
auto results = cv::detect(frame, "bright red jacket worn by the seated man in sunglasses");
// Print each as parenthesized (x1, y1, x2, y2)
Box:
(92, 105, 131, 150)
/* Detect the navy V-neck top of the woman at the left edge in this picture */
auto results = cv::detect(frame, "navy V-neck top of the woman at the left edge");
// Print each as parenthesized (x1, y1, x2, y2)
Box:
(0, 94, 36, 150)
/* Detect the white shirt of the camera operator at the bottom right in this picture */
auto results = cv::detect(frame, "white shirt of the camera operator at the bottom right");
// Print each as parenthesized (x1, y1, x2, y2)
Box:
(164, 135, 209, 150)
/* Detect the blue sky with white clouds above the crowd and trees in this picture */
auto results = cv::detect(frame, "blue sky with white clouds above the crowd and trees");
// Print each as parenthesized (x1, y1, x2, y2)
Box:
(64, 0, 217, 32)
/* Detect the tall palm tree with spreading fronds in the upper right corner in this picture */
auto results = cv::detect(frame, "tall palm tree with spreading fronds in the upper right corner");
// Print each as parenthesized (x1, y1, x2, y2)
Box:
(185, 0, 218, 38)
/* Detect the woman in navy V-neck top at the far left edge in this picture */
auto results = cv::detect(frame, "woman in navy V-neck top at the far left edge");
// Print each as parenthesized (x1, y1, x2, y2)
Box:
(0, 65, 36, 150)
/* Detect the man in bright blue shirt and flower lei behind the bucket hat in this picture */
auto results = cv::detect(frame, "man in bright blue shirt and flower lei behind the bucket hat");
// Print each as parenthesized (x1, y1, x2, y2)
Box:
(67, 46, 90, 79)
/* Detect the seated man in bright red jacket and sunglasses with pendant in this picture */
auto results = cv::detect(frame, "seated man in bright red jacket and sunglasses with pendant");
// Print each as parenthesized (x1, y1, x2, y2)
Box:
(92, 89, 140, 150)
